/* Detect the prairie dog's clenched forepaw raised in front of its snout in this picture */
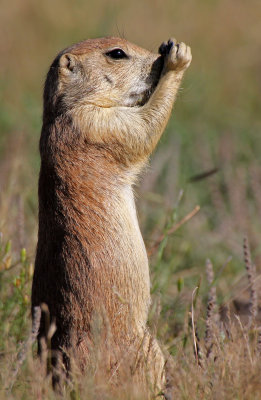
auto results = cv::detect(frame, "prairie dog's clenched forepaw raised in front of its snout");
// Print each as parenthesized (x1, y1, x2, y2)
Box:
(159, 39, 192, 71)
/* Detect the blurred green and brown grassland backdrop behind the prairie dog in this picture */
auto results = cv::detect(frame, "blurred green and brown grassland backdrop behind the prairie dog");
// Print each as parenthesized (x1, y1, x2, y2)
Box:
(0, 0, 261, 340)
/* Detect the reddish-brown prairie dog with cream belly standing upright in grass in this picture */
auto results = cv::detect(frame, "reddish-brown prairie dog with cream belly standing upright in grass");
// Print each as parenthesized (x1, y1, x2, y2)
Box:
(32, 37, 191, 398)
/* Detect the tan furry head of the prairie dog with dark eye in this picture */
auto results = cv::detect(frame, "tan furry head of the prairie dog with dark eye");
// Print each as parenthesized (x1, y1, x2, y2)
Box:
(44, 37, 163, 121)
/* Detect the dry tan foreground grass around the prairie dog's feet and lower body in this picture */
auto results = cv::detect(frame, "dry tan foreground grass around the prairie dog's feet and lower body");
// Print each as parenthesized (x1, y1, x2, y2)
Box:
(0, 240, 261, 400)
